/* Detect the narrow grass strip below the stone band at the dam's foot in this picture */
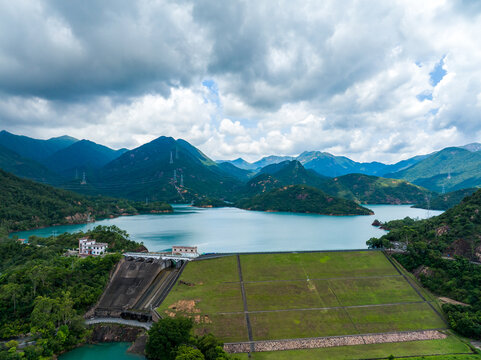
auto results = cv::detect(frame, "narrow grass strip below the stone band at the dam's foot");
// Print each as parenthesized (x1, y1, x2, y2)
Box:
(242, 336, 474, 360)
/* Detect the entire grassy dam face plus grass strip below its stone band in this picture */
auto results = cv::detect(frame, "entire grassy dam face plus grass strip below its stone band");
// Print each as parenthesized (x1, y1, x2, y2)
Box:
(158, 251, 469, 359)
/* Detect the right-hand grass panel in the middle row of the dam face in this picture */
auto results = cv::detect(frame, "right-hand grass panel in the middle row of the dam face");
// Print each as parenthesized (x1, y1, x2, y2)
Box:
(326, 276, 421, 306)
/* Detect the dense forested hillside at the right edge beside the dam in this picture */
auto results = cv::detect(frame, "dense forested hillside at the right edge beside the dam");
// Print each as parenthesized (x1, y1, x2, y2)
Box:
(367, 190, 481, 339)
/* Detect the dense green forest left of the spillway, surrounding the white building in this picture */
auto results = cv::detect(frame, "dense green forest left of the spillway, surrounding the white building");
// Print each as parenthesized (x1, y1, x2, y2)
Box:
(0, 226, 142, 359)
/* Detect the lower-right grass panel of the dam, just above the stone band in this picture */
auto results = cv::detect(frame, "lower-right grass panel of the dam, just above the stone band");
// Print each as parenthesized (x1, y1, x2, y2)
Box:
(346, 303, 446, 334)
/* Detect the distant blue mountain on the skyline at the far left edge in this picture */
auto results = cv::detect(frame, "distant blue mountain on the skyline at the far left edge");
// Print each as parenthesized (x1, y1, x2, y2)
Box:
(0, 130, 78, 161)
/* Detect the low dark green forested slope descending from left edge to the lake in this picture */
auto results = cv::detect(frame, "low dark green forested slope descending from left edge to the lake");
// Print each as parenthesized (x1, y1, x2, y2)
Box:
(0, 170, 172, 231)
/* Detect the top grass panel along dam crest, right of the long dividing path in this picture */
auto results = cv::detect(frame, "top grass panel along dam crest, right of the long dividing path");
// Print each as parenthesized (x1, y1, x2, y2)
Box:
(241, 251, 398, 281)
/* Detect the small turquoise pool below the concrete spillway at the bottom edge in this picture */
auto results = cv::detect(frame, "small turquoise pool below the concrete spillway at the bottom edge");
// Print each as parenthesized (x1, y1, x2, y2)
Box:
(59, 342, 145, 360)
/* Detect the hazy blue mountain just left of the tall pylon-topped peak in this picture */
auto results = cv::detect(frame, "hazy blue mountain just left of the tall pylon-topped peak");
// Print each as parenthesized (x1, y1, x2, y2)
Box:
(42, 140, 126, 178)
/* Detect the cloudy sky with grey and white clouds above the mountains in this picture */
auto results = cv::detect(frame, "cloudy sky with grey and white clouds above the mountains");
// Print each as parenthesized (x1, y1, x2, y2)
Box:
(0, 0, 481, 163)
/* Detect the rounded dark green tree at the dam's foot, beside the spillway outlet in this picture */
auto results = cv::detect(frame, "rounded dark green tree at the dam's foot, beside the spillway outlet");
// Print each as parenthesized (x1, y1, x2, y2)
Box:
(145, 317, 193, 360)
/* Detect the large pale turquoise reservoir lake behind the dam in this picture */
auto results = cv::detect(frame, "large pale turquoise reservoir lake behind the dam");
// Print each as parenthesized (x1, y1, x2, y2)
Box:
(9, 205, 441, 252)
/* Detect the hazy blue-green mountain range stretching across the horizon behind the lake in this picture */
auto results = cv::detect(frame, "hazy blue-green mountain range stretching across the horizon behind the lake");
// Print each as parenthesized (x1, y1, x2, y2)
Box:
(0, 131, 481, 207)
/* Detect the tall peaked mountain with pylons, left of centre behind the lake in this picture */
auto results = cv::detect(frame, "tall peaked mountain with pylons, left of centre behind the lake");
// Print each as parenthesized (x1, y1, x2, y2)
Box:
(81, 136, 242, 202)
